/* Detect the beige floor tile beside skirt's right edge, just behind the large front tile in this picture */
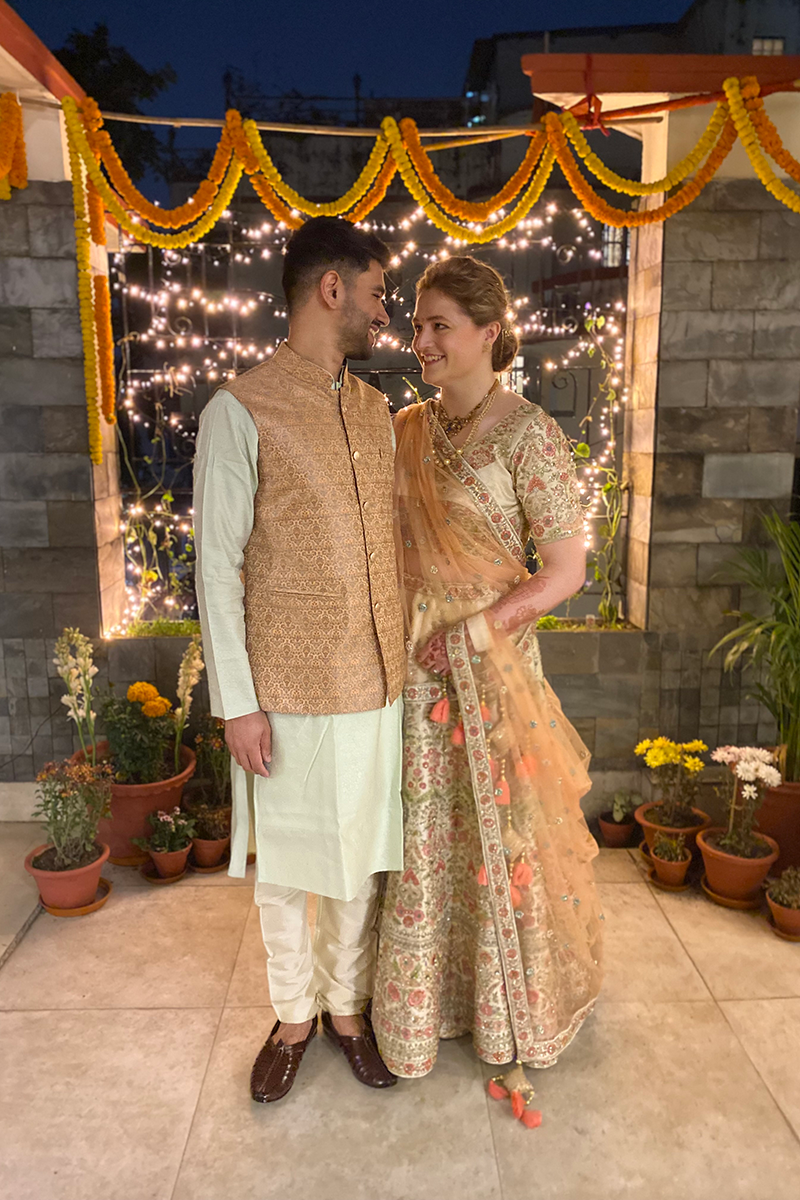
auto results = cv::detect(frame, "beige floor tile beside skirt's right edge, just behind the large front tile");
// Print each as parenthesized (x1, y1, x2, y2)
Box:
(599, 883, 709, 1001)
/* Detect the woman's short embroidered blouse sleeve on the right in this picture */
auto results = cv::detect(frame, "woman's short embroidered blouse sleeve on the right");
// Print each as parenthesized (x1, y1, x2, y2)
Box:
(512, 409, 584, 547)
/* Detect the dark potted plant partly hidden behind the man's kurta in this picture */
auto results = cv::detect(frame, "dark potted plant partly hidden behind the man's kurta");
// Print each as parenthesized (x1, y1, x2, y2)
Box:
(188, 714, 230, 869)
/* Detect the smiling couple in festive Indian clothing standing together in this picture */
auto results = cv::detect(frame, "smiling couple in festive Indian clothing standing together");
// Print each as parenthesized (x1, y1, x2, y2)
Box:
(194, 217, 601, 1103)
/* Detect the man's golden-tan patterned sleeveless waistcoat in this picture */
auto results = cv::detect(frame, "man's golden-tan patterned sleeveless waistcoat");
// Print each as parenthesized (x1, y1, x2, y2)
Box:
(225, 342, 405, 714)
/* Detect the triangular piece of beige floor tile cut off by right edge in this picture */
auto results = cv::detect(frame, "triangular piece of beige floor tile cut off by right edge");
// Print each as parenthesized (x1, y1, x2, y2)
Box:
(720, 1000, 800, 1138)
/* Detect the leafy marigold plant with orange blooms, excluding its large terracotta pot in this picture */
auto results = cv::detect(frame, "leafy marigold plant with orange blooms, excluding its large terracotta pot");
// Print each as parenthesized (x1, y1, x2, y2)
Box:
(102, 683, 175, 784)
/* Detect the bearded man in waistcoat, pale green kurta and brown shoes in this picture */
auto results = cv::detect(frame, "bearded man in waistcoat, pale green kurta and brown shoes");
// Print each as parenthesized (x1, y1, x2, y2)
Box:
(194, 217, 405, 1103)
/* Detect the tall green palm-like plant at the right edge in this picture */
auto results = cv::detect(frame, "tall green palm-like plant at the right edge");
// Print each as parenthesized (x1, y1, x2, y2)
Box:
(711, 512, 800, 782)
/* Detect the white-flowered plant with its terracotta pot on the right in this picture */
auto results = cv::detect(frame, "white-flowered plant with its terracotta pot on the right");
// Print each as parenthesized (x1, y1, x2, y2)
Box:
(697, 746, 781, 901)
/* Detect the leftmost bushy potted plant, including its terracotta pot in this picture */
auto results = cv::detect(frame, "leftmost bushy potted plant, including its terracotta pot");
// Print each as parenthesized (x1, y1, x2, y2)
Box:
(25, 762, 112, 911)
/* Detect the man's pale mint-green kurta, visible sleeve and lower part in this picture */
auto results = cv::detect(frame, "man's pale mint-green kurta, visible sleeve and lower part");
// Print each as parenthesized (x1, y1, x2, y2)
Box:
(194, 390, 403, 900)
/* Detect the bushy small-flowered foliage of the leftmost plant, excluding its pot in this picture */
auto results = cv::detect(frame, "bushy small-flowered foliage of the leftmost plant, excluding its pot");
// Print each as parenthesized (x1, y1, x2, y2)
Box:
(34, 762, 112, 871)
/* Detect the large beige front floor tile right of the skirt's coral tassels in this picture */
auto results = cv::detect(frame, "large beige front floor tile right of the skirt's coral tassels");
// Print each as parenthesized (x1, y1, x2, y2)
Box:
(484, 1001, 800, 1200)
